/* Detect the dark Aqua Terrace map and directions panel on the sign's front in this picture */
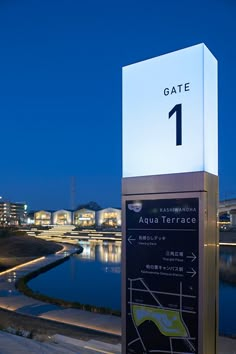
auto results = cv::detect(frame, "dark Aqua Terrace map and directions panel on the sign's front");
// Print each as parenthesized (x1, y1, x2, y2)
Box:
(125, 198, 199, 354)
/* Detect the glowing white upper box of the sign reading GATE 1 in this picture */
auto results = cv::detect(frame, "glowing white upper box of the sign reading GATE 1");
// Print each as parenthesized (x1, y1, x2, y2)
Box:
(123, 44, 218, 177)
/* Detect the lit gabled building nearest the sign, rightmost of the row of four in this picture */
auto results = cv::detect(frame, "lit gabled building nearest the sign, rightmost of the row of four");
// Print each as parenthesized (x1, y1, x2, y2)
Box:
(96, 208, 121, 228)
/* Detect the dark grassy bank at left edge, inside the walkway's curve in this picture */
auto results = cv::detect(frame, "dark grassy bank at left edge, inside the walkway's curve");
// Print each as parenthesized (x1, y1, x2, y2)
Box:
(0, 229, 62, 271)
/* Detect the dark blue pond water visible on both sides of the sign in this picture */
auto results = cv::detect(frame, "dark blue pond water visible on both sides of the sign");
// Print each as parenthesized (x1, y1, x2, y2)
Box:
(29, 242, 236, 335)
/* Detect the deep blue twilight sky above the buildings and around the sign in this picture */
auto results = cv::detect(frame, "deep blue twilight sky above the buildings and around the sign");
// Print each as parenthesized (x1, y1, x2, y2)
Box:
(0, 0, 236, 209)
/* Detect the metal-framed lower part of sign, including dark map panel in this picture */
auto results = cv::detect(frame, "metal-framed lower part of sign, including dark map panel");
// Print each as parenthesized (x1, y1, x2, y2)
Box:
(122, 172, 219, 354)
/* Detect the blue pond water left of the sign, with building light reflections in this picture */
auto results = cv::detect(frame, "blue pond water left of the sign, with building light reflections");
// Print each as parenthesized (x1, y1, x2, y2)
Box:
(29, 241, 121, 310)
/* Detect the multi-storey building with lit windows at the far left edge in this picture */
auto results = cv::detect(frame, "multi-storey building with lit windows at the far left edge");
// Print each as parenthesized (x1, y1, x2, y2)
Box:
(0, 200, 27, 226)
